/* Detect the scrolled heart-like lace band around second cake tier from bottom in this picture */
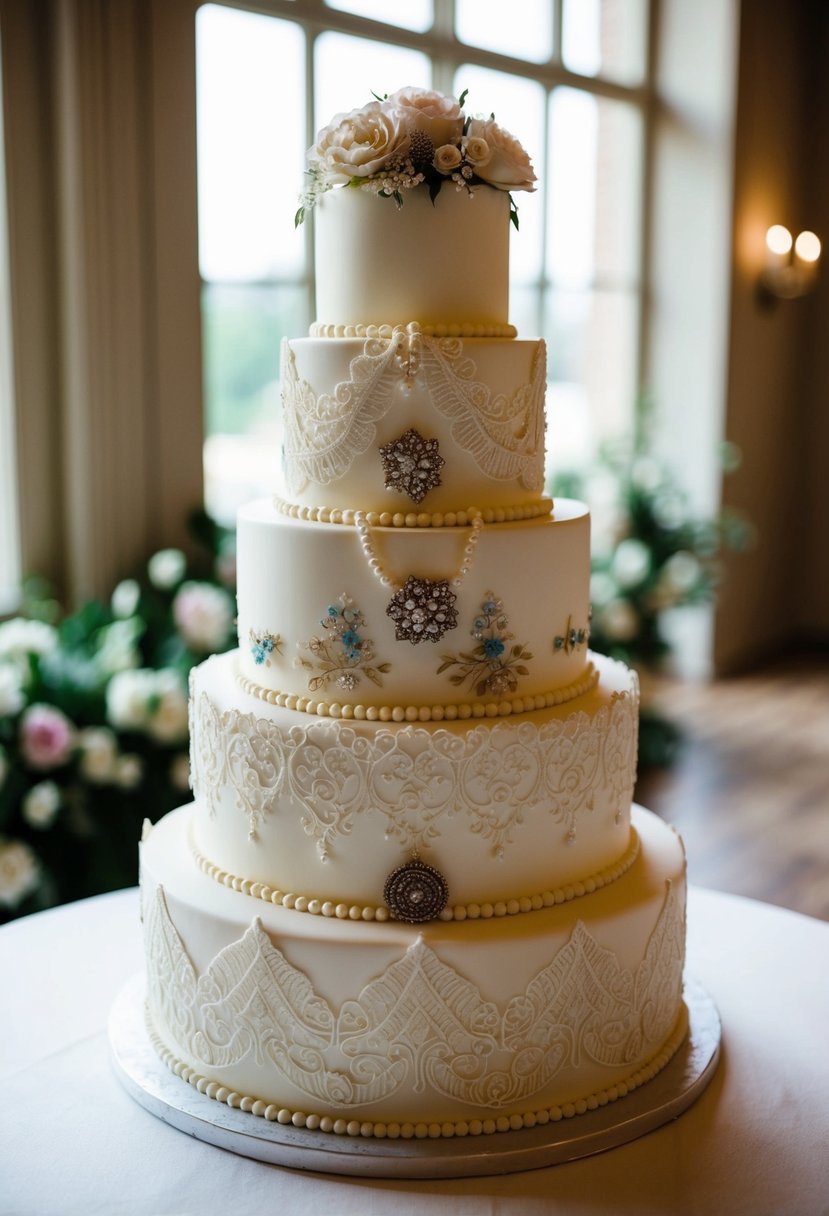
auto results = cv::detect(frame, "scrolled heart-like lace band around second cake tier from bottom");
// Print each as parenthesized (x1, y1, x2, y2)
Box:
(191, 692, 638, 857)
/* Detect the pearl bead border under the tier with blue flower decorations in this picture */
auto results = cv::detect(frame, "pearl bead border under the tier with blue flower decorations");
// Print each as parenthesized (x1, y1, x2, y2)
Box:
(236, 663, 599, 722)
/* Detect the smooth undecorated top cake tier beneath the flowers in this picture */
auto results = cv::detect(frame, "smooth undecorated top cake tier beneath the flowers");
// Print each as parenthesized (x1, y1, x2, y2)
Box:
(311, 184, 515, 337)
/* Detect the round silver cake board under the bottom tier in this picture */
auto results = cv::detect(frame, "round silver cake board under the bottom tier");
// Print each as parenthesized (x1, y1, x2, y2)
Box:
(109, 975, 721, 1178)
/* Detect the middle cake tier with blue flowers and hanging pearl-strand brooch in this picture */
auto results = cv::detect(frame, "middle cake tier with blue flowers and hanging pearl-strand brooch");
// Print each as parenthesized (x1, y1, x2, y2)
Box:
(237, 500, 593, 705)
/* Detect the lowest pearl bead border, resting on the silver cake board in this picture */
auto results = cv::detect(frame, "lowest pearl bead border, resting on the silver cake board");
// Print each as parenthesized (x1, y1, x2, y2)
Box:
(146, 1004, 688, 1139)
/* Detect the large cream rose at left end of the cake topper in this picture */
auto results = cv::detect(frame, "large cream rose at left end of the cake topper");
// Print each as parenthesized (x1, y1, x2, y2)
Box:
(309, 101, 410, 187)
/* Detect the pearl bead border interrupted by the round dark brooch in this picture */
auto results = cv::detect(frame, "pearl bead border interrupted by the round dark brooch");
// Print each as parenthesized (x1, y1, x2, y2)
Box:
(191, 827, 639, 921)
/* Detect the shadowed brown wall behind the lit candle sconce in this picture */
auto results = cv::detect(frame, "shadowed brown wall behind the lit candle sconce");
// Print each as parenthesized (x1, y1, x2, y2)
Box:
(715, 0, 829, 671)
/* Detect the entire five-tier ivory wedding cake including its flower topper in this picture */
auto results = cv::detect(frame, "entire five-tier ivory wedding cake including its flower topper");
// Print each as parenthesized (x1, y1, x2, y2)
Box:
(141, 90, 686, 1137)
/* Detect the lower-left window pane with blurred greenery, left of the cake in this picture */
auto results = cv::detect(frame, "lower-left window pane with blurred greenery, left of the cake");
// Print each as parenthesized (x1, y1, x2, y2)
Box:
(202, 285, 309, 522)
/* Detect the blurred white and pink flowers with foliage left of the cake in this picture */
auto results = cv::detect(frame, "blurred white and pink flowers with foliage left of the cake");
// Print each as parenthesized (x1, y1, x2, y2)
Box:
(0, 516, 236, 921)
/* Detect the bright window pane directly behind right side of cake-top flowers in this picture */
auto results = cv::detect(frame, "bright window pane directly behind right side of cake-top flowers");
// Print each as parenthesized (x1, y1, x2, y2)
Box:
(455, 63, 545, 284)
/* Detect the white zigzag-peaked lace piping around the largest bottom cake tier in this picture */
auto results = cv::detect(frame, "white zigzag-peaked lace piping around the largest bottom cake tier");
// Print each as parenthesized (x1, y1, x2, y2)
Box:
(143, 882, 684, 1111)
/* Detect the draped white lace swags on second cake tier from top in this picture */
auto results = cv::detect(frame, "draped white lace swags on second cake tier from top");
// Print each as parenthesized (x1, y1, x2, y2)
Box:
(282, 325, 547, 494)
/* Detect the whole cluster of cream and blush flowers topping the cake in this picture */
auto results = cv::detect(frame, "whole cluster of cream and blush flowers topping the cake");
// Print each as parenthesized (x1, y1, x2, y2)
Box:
(295, 88, 536, 226)
